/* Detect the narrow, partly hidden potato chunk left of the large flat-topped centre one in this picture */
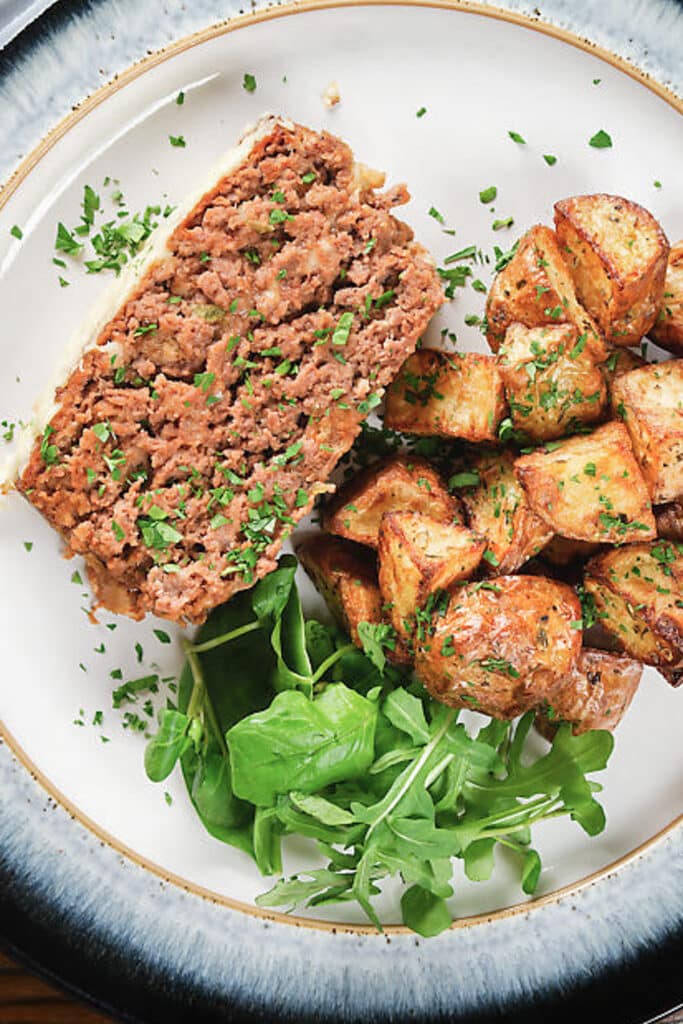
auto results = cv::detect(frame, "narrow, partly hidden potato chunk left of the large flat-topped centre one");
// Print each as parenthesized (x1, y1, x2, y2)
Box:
(455, 450, 553, 574)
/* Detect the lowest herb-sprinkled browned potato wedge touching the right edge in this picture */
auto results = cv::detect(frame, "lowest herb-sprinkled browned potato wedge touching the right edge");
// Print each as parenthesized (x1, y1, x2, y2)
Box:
(584, 541, 683, 668)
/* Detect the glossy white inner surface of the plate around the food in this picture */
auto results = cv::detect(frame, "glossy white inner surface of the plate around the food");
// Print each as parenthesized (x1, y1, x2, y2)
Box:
(0, 0, 683, 921)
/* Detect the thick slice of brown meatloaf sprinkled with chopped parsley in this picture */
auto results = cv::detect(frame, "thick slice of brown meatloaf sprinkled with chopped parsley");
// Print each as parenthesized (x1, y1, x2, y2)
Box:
(17, 118, 442, 623)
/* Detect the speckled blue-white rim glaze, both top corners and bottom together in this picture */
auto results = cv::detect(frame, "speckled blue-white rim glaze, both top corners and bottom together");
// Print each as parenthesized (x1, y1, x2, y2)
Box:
(0, 0, 683, 1024)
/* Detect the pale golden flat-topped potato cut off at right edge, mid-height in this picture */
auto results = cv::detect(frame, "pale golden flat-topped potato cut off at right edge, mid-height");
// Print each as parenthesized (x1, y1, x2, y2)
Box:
(611, 359, 683, 504)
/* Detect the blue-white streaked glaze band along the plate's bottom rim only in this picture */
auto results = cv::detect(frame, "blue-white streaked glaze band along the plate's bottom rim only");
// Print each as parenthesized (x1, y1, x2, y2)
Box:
(0, 733, 683, 1021)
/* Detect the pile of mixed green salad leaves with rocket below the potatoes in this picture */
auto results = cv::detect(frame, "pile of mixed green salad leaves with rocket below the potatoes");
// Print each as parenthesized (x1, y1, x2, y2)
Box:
(144, 555, 612, 936)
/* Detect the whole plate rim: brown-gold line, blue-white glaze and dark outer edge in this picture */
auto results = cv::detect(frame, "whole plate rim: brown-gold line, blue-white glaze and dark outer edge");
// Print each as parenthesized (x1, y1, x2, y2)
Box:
(0, 0, 683, 1024)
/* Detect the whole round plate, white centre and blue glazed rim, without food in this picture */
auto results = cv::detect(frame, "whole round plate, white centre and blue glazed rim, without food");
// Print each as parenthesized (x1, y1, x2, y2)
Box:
(0, 3, 683, 1021)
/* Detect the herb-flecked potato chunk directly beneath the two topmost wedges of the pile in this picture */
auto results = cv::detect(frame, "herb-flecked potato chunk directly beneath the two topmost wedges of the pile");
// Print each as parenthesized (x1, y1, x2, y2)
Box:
(498, 324, 607, 441)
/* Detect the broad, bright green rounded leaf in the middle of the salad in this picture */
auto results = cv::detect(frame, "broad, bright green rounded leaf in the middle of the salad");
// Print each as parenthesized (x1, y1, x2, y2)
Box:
(226, 683, 377, 806)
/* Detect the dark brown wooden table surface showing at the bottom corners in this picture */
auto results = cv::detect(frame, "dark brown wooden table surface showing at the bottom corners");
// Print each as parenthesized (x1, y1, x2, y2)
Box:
(0, 950, 683, 1024)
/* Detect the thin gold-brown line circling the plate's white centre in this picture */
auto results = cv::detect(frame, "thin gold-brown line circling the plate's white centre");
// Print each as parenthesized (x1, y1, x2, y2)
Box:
(0, 0, 683, 935)
